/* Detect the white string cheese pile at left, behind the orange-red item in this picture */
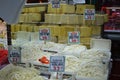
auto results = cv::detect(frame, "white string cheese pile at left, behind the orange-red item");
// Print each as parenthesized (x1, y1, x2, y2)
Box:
(21, 41, 65, 62)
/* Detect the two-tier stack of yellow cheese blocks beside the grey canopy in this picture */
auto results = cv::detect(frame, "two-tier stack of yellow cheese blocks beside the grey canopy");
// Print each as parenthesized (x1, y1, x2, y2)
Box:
(19, 6, 46, 22)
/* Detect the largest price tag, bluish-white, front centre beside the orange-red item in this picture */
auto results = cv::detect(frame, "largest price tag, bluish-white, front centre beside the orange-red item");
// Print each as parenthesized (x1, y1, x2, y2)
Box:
(49, 56, 65, 72)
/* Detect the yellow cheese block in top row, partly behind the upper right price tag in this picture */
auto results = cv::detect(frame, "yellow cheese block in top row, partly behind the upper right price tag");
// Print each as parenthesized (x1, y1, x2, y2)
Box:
(76, 4, 95, 14)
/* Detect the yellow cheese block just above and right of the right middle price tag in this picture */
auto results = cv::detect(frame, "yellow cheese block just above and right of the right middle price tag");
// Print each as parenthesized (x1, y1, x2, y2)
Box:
(80, 26, 92, 37)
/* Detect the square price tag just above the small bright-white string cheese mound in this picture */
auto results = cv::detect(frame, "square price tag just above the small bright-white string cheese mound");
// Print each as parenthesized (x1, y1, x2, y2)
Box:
(68, 32, 80, 44)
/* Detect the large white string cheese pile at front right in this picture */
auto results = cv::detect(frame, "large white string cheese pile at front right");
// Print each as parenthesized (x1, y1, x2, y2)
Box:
(77, 49, 111, 80)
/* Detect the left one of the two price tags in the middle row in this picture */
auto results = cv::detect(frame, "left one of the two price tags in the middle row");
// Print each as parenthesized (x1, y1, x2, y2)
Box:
(39, 29, 50, 40)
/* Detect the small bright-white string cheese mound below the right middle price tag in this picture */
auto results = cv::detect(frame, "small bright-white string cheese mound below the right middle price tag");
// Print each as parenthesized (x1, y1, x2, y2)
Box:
(62, 45, 87, 57)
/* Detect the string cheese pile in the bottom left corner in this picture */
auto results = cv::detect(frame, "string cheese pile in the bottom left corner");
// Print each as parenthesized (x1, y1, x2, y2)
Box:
(0, 64, 44, 80)
